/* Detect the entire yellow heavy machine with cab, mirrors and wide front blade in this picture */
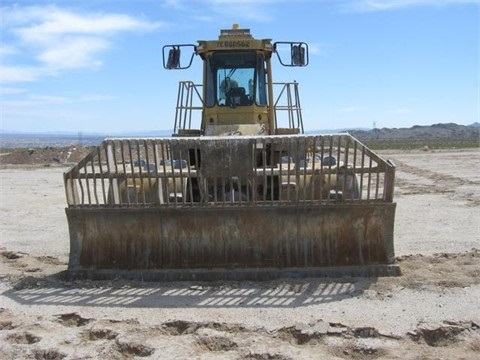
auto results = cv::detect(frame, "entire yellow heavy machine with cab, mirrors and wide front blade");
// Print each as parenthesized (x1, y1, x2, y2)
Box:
(64, 25, 398, 281)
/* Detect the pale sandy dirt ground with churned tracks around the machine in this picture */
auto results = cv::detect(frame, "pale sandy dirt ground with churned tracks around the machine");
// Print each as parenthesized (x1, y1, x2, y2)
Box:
(0, 149, 480, 360)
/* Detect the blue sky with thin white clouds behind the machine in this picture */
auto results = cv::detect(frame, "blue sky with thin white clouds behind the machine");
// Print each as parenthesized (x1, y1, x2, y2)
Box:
(0, 0, 480, 135)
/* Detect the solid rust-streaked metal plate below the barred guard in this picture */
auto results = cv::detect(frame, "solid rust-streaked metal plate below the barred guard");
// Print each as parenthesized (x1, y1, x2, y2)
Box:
(67, 204, 394, 269)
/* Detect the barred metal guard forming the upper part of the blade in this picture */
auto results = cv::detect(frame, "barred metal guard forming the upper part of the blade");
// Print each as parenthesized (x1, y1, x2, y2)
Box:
(64, 134, 395, 207)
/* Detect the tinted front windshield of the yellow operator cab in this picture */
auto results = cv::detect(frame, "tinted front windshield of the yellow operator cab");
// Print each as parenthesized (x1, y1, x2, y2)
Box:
(205, 51, 267, 107)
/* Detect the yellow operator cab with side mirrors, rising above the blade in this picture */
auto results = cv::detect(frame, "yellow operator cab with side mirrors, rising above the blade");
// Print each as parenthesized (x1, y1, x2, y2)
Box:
(163, 24, 308, 136)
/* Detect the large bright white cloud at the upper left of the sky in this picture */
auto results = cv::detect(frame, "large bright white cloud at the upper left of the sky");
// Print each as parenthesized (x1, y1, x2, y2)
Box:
(0, 6, 163, 82)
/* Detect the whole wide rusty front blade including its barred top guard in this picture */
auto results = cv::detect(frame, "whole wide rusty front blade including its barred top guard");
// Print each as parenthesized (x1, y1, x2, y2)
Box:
(64, 134, 399, 281)
